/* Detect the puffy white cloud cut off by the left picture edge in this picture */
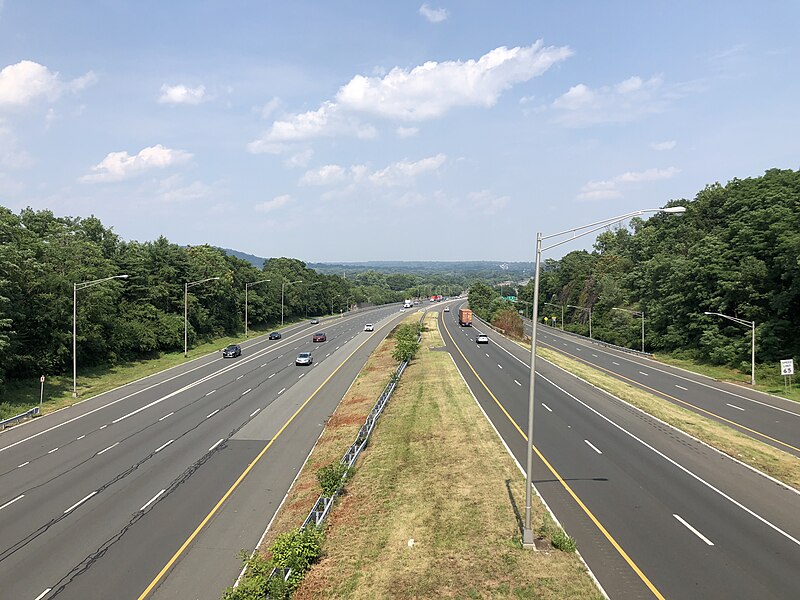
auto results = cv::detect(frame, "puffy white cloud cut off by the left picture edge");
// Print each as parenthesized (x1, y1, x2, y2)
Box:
(0, 60, 97, 106)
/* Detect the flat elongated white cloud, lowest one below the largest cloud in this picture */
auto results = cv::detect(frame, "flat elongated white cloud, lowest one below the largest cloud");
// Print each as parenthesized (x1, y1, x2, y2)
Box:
(299, 154, 447, 187)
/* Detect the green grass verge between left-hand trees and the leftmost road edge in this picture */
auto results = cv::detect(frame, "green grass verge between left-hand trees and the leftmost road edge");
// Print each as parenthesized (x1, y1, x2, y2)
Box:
(0, 319, 305, 420)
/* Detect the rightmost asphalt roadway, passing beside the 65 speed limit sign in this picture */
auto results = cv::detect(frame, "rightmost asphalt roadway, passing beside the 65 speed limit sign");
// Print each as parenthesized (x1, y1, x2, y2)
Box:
(526, 320, 800, 457)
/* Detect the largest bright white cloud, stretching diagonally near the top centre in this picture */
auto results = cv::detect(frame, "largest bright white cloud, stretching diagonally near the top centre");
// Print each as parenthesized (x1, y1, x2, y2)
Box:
(336, 41, 572, 121)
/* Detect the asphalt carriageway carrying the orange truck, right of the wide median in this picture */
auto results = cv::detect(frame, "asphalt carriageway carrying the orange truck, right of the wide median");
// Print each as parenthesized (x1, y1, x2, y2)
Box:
(440, 310, 800, 600)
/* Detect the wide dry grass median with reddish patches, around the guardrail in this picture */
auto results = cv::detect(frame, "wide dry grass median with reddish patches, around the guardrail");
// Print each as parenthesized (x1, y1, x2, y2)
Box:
(290, 314, 602, 600)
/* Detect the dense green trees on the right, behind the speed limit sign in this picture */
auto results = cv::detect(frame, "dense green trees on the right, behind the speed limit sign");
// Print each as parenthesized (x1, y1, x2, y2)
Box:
(470, 169, 800, 373)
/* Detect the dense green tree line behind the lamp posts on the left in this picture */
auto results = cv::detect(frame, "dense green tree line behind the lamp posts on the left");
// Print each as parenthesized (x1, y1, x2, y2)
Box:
(0, 207, 424, 392)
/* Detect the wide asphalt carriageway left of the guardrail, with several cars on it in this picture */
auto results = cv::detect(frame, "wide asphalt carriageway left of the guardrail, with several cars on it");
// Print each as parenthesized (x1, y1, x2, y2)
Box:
(0, 305, 405, 600)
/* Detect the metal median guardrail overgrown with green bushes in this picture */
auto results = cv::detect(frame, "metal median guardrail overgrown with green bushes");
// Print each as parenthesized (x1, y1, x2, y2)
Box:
(222, 313, 425, 600)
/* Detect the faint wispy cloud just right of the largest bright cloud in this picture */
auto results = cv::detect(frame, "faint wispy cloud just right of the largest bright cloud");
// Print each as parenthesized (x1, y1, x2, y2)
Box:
(551, 77, 676, 127)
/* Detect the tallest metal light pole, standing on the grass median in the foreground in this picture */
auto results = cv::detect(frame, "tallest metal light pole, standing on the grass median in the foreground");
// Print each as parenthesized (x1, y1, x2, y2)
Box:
(522, 206, 686, 549)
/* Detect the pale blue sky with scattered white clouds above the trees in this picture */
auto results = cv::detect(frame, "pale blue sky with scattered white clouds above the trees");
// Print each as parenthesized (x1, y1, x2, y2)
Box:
(0, 0, 800, 262)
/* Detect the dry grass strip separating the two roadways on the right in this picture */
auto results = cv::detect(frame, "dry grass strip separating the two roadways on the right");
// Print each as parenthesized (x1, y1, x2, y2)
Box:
(537, 347, 800, 488)
